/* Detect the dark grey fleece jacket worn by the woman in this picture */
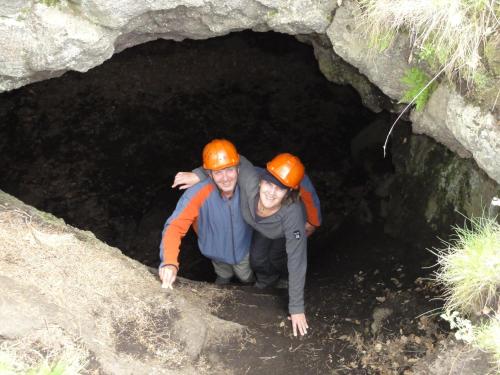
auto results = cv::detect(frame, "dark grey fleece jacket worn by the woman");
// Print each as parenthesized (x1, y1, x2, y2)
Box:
(193, 155, 307, 314)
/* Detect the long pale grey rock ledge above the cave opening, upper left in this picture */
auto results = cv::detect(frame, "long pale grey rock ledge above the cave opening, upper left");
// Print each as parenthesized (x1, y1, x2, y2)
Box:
(0, 0, 336, 92)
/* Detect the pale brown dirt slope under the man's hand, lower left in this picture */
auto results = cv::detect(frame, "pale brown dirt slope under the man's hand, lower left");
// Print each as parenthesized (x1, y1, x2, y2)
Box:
(0, 190, 243, 375)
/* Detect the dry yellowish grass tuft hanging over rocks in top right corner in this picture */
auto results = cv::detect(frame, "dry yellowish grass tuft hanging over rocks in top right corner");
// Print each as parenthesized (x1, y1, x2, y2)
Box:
(359, 0, 500, 83)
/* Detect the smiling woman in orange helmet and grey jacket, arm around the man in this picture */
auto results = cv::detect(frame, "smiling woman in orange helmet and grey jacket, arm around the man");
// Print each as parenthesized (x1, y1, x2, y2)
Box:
(173, 148, 320, 336)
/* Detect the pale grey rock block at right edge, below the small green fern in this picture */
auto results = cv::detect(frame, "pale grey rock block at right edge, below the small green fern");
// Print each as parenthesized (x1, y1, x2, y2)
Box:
(411, 84, 500, 182)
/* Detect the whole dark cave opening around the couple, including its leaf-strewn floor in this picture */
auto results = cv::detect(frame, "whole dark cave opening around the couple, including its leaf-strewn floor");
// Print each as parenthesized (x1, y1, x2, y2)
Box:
(0, 32, 444, 374)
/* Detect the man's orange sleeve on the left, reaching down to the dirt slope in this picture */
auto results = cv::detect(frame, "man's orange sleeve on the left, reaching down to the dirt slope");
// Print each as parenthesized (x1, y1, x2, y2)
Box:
(161, 184, 213, 268)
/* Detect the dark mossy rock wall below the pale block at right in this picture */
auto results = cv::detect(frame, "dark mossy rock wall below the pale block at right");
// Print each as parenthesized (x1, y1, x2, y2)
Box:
(385, 134, 500, 248)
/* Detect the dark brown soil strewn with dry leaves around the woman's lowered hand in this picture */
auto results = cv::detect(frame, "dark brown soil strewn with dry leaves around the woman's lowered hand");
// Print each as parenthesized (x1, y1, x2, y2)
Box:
(201, 220, 447, 375)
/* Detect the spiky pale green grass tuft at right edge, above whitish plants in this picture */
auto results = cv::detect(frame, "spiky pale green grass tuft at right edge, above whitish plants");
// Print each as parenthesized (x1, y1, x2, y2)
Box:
(434, 213, 500, 315)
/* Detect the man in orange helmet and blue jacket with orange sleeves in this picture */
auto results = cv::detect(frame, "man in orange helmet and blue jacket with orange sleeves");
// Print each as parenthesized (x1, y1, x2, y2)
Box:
(160, 139, 254, 289)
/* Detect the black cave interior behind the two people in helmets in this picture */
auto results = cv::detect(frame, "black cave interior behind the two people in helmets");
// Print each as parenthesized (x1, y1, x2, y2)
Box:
(0, 32, 430, 280)
